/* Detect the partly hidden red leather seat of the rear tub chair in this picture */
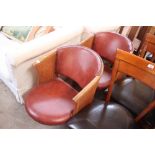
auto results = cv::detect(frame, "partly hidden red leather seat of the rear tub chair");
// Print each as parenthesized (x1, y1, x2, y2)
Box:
(98, 65, 112, 89)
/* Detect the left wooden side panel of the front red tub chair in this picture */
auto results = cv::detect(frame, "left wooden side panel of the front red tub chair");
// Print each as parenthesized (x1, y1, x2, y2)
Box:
(33, 51, 56, 84)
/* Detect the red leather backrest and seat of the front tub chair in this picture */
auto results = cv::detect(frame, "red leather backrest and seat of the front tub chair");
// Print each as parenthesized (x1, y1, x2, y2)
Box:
(25, 46, 102, 124)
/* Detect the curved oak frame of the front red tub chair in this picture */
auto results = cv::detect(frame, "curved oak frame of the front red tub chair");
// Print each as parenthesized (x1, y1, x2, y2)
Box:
(25, 46, 103, 124)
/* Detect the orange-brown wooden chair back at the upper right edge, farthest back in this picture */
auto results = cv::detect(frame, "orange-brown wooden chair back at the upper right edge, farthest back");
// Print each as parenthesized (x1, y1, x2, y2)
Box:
(140, 33, 155, 61)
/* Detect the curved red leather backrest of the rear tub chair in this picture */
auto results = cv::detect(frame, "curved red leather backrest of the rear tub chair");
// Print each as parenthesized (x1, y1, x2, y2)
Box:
(92, 32, 133, 63)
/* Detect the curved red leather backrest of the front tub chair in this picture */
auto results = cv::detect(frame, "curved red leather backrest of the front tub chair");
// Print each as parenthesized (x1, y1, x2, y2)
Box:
(56, 46, 102, 88)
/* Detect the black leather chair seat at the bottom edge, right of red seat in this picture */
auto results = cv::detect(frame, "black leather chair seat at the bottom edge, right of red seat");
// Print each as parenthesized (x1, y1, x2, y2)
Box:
(67, 100, 135, 129)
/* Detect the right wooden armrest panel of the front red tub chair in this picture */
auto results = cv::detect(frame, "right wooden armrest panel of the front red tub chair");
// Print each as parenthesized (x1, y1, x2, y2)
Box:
(73, 76, 100, 114)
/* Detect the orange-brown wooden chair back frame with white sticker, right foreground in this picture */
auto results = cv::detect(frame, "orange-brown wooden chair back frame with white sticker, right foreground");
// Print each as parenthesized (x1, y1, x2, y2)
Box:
(106, 49, 155, 121)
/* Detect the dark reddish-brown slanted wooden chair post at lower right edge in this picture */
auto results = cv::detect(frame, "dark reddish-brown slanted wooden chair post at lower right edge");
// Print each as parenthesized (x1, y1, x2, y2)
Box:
(135, 101, 155, 122)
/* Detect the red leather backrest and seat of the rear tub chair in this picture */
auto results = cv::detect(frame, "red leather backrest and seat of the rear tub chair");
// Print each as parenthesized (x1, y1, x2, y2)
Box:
(93, 32, 133, 89)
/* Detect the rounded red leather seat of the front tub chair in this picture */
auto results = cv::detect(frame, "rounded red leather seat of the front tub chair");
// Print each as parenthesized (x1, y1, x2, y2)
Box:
(25, 79, 78, 124)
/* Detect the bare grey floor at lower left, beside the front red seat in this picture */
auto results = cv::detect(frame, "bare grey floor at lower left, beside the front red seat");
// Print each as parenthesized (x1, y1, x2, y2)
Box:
(0, 80, 66, 129)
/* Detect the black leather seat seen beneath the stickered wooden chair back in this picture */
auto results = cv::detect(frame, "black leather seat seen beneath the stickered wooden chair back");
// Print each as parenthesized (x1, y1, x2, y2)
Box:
(112, 78, 155, 114)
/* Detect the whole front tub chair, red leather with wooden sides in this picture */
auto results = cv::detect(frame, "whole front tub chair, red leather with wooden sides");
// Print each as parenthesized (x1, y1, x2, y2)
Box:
(25, 46, 103, 124)
